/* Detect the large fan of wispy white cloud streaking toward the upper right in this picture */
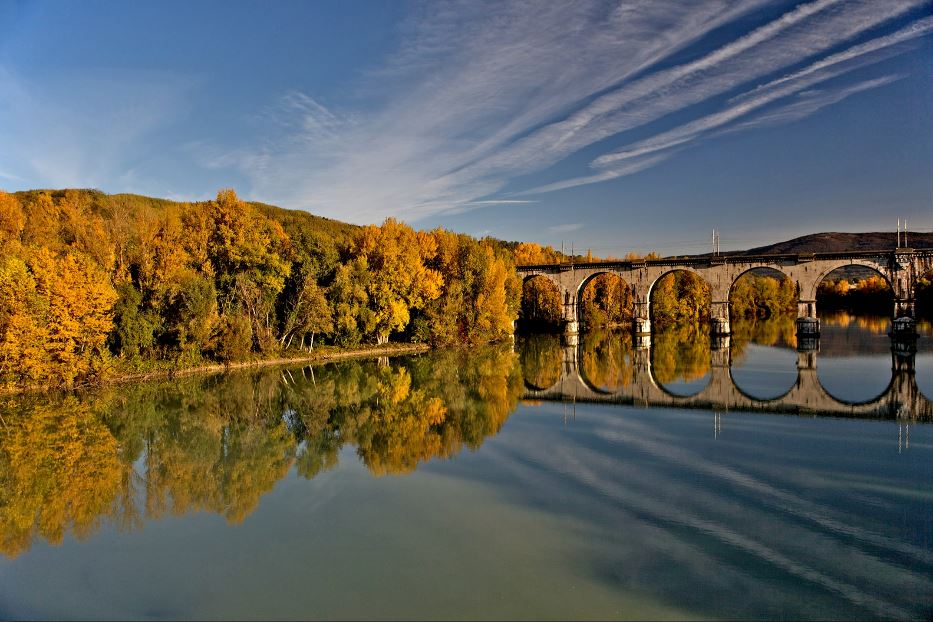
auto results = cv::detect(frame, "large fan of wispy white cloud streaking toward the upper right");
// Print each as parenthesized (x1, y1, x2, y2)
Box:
(205, 0, 928, 221)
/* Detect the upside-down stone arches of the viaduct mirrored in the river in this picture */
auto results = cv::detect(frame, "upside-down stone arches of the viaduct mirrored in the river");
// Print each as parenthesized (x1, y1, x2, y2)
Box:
(524, 338, 933, 421)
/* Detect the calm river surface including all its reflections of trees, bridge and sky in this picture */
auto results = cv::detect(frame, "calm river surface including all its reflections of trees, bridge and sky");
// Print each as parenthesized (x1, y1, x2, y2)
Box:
(0, 315, 933, 619)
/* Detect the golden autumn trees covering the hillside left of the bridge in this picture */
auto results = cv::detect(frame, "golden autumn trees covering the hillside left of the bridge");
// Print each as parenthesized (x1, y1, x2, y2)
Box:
(0, 189, 524, 388)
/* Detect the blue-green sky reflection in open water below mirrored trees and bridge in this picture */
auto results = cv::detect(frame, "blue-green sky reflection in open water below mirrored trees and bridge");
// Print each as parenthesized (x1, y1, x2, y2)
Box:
(0, 404, 933, 618)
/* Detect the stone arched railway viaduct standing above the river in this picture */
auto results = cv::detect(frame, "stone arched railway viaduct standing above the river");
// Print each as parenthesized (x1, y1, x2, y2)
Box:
(516, 248, 933, 335)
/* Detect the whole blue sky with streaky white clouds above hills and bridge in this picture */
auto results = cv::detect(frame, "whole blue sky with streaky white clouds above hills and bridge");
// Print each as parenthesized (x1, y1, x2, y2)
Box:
(0, 0, 933, 257)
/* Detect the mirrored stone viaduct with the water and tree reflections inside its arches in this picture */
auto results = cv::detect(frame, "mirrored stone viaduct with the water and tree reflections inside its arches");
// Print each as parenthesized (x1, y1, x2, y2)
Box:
(526, 317, 933, 421)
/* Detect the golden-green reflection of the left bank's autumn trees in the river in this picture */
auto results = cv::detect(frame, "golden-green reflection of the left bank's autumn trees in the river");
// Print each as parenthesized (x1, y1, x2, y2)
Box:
(0, 347, 523, 556)
